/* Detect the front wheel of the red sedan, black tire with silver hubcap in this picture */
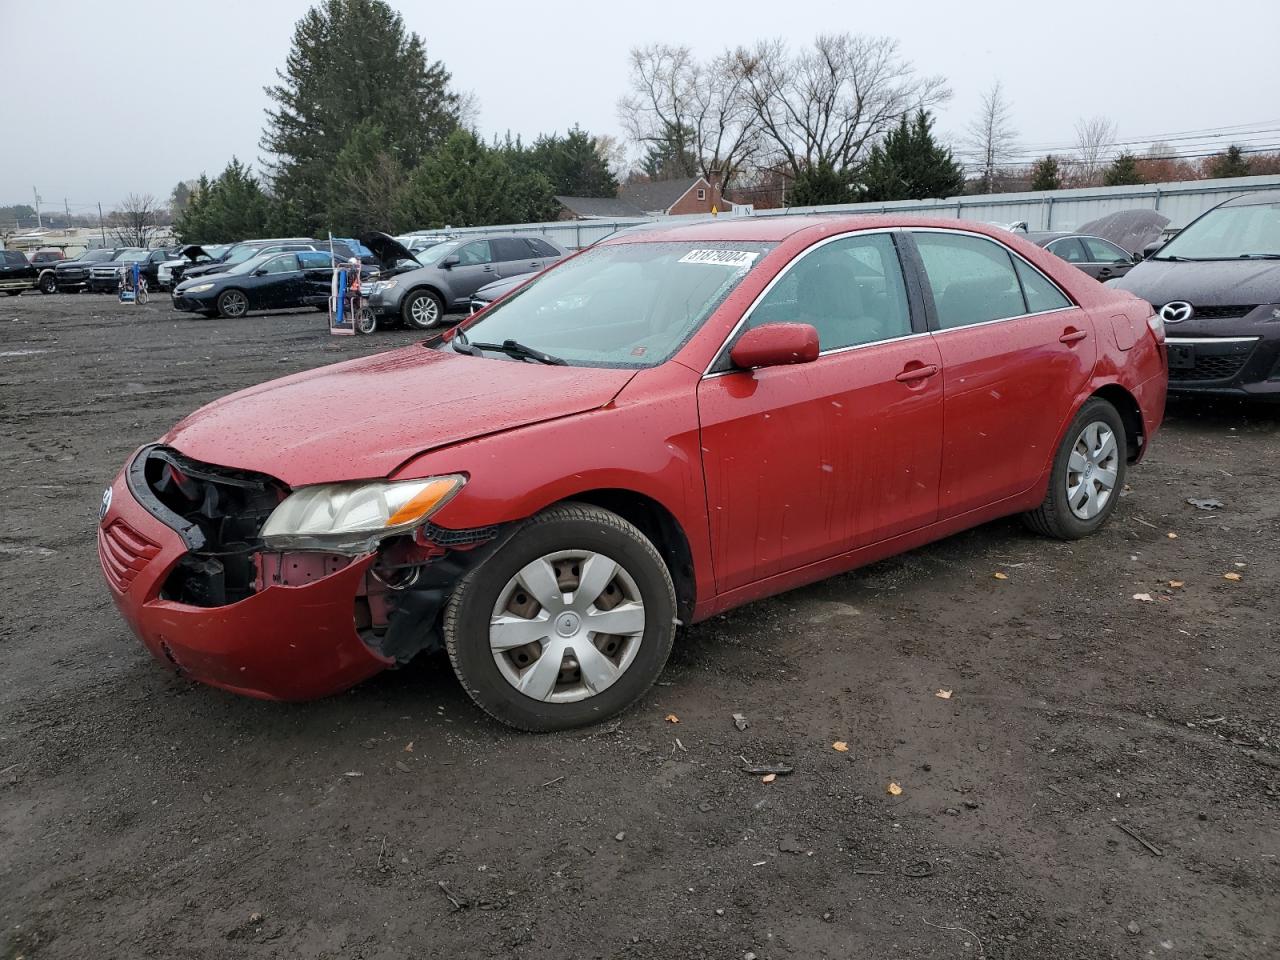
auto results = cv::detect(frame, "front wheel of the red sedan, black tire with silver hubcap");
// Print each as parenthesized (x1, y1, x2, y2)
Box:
(444, 503, 676, 732)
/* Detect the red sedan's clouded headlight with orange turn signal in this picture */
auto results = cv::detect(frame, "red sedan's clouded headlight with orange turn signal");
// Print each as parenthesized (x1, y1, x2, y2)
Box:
(262, 474, 466, 553)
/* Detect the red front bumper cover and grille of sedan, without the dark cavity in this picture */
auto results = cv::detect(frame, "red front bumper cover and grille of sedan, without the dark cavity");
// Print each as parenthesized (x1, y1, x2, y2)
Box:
(97, 463, 393, 700)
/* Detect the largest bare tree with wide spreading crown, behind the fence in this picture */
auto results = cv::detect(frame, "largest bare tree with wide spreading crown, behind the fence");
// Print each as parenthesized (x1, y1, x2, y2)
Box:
(732, 33, 951, 177)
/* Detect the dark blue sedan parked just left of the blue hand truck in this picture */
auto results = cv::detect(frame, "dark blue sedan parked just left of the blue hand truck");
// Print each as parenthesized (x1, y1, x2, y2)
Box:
(173, 250, 374, 317)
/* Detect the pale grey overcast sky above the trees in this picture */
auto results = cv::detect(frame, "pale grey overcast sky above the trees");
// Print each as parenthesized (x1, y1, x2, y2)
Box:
(0, 0, 1280, 212)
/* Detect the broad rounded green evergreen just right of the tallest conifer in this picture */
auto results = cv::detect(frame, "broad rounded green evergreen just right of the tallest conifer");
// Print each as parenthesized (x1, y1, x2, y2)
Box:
(401, 129, 552, 229)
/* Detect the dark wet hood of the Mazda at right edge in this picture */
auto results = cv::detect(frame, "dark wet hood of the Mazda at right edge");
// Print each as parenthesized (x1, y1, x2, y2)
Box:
(1107, 260, 1280, 307)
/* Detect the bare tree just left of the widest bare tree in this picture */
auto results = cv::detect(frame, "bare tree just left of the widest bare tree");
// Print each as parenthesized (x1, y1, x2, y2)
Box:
(618, 44, 759, 186)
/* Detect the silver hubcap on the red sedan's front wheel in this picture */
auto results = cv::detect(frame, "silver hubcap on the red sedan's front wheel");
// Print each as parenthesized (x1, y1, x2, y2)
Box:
(489, 550, 645, 703)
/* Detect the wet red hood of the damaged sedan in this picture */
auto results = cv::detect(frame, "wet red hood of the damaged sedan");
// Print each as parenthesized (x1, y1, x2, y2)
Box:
(163, 344, 635, 486)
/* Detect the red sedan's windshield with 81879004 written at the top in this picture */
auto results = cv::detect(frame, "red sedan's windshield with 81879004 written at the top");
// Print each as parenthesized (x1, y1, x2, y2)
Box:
(455, 241, 774, 367)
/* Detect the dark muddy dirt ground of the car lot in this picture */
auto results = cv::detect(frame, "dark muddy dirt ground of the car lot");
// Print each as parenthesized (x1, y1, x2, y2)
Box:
(0, 294, 1280, 960)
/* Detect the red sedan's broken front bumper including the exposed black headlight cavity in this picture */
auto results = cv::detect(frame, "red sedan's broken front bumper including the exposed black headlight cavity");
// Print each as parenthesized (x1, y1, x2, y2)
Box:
(97, 447, 498, 700)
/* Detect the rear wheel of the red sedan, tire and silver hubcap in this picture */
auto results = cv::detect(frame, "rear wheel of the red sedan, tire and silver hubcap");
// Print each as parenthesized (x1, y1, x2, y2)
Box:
(1023, 397, 1128, 540)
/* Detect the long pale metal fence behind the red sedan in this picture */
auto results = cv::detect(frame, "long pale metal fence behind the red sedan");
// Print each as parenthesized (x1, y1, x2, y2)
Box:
(437, 177, 1280, 250)
